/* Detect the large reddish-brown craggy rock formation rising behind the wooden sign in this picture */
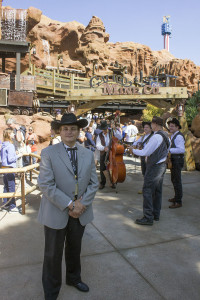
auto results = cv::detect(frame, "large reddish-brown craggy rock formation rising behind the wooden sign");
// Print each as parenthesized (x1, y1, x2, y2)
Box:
(1, 7, 200, 92)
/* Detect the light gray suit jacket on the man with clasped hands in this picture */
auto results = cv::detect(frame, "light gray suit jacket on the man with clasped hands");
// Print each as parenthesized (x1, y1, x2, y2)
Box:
(38, 142, 98, 229)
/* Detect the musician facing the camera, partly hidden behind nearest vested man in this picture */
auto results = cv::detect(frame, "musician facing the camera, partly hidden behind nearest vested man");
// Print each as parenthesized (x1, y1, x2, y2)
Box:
(133, 122, 153, 176)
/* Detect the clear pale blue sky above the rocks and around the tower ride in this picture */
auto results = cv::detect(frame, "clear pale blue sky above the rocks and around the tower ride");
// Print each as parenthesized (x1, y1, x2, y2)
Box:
(3, 0, 200, 65)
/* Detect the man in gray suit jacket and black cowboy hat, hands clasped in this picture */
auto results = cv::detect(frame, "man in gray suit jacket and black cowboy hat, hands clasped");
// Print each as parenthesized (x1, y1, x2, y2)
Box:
(38, 113, 98, 300)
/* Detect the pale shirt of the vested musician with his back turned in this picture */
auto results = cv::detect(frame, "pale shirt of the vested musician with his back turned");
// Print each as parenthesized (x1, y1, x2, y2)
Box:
(133, 131, 170, 164)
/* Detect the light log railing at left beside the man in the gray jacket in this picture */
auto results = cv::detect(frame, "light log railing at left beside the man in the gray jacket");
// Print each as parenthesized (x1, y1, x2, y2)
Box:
(0, 153, 41, 215)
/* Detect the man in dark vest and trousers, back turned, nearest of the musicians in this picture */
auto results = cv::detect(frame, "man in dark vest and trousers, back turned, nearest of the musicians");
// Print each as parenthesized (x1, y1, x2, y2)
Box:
(132, 117, 170, 225)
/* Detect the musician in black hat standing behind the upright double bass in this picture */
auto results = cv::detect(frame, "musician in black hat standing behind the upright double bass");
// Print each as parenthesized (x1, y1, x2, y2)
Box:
(96, 121, 122, 190)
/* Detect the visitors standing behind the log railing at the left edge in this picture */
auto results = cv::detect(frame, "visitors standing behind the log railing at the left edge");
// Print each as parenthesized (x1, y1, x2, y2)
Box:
(1, 118, 38, 213)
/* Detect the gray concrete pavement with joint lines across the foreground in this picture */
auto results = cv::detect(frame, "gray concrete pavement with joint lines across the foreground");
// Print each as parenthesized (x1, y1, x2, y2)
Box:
(0, 158, 200, 300)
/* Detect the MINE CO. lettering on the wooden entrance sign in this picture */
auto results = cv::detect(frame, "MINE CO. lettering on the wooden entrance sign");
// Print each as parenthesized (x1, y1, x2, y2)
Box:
(102, 83, 159, 95)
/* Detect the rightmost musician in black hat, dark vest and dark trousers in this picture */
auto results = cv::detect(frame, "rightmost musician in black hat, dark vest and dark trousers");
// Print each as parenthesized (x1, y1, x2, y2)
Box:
(167, 118, 185, 208)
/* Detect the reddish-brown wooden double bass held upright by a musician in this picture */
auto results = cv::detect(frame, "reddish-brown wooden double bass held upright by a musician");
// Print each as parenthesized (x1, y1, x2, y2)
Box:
(104, 122, 126, 186)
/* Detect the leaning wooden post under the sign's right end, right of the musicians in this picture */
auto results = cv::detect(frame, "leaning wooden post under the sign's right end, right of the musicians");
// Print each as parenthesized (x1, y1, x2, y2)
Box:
(179, 112, 196, 171)
